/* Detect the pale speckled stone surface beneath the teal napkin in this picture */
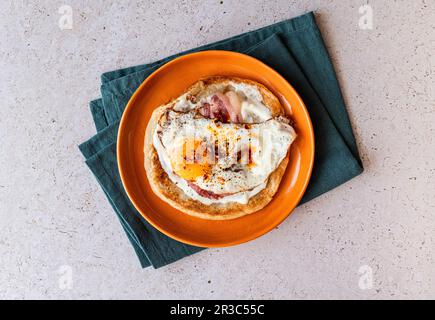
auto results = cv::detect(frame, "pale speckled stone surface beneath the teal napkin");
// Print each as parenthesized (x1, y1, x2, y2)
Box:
(0, 0, 435, 299)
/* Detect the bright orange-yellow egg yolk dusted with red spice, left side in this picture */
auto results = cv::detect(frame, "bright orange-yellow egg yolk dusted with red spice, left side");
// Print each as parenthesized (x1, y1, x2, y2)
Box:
(171, 140, 211, 181)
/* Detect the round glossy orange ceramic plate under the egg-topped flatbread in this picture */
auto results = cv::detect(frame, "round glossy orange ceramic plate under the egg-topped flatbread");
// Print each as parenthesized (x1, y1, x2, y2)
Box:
(117, 51, 314, 247)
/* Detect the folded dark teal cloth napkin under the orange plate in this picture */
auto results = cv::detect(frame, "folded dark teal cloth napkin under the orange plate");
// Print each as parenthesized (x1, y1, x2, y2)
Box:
(79, 12, 363, 268)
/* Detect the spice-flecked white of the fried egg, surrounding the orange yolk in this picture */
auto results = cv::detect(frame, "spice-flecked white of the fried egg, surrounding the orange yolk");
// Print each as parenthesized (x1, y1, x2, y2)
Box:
(153, 110, 296, 204)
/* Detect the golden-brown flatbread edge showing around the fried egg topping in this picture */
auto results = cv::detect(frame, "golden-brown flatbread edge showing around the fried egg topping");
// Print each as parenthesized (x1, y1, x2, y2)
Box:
(144, 77, 288, 220)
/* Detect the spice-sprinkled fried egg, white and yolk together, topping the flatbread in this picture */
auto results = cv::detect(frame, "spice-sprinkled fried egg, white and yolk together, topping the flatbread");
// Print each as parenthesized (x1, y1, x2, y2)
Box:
(153, 84, 296, 205)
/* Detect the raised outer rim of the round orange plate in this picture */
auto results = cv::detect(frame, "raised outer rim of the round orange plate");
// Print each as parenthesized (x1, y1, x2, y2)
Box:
(116, 50, 315, 248)
